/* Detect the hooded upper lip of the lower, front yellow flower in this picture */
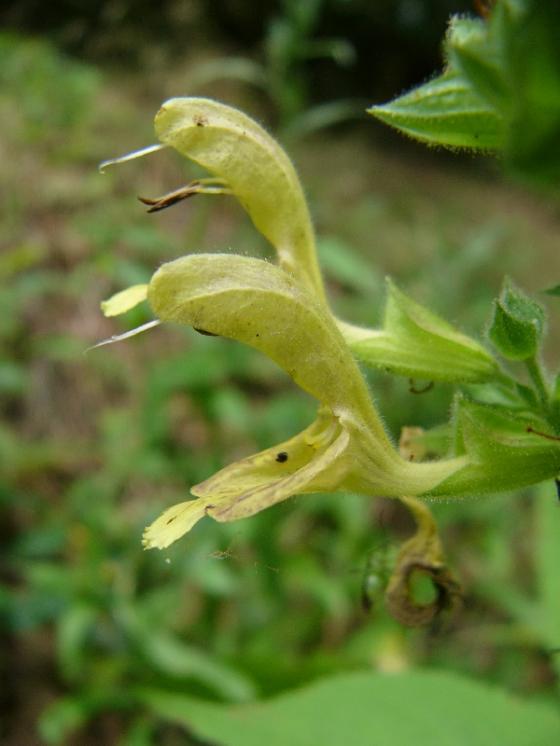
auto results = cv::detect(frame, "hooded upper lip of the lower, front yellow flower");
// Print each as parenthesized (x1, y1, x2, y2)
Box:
(148, 254, 382, 430)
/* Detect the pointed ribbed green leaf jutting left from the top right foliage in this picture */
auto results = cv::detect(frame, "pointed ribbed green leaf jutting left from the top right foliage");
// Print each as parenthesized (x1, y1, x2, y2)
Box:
(368, 69, 504, 150)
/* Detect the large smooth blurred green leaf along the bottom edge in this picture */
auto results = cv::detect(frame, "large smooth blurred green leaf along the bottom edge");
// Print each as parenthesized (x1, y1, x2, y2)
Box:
(139, 671, 560, 746)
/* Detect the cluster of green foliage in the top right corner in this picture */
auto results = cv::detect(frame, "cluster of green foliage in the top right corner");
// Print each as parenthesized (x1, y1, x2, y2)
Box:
(370, 0, 560, 190)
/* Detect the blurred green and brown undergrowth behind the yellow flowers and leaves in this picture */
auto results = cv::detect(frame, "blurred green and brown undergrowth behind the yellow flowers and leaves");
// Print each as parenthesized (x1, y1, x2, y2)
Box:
(0, 0, 560, 746)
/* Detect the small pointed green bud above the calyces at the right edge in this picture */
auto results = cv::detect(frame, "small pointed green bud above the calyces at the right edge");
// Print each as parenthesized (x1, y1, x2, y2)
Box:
(488, 279, 545, 360)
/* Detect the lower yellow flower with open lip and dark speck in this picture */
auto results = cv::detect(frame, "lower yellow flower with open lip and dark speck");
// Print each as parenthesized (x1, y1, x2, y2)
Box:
(106, 254, 465, 548)
